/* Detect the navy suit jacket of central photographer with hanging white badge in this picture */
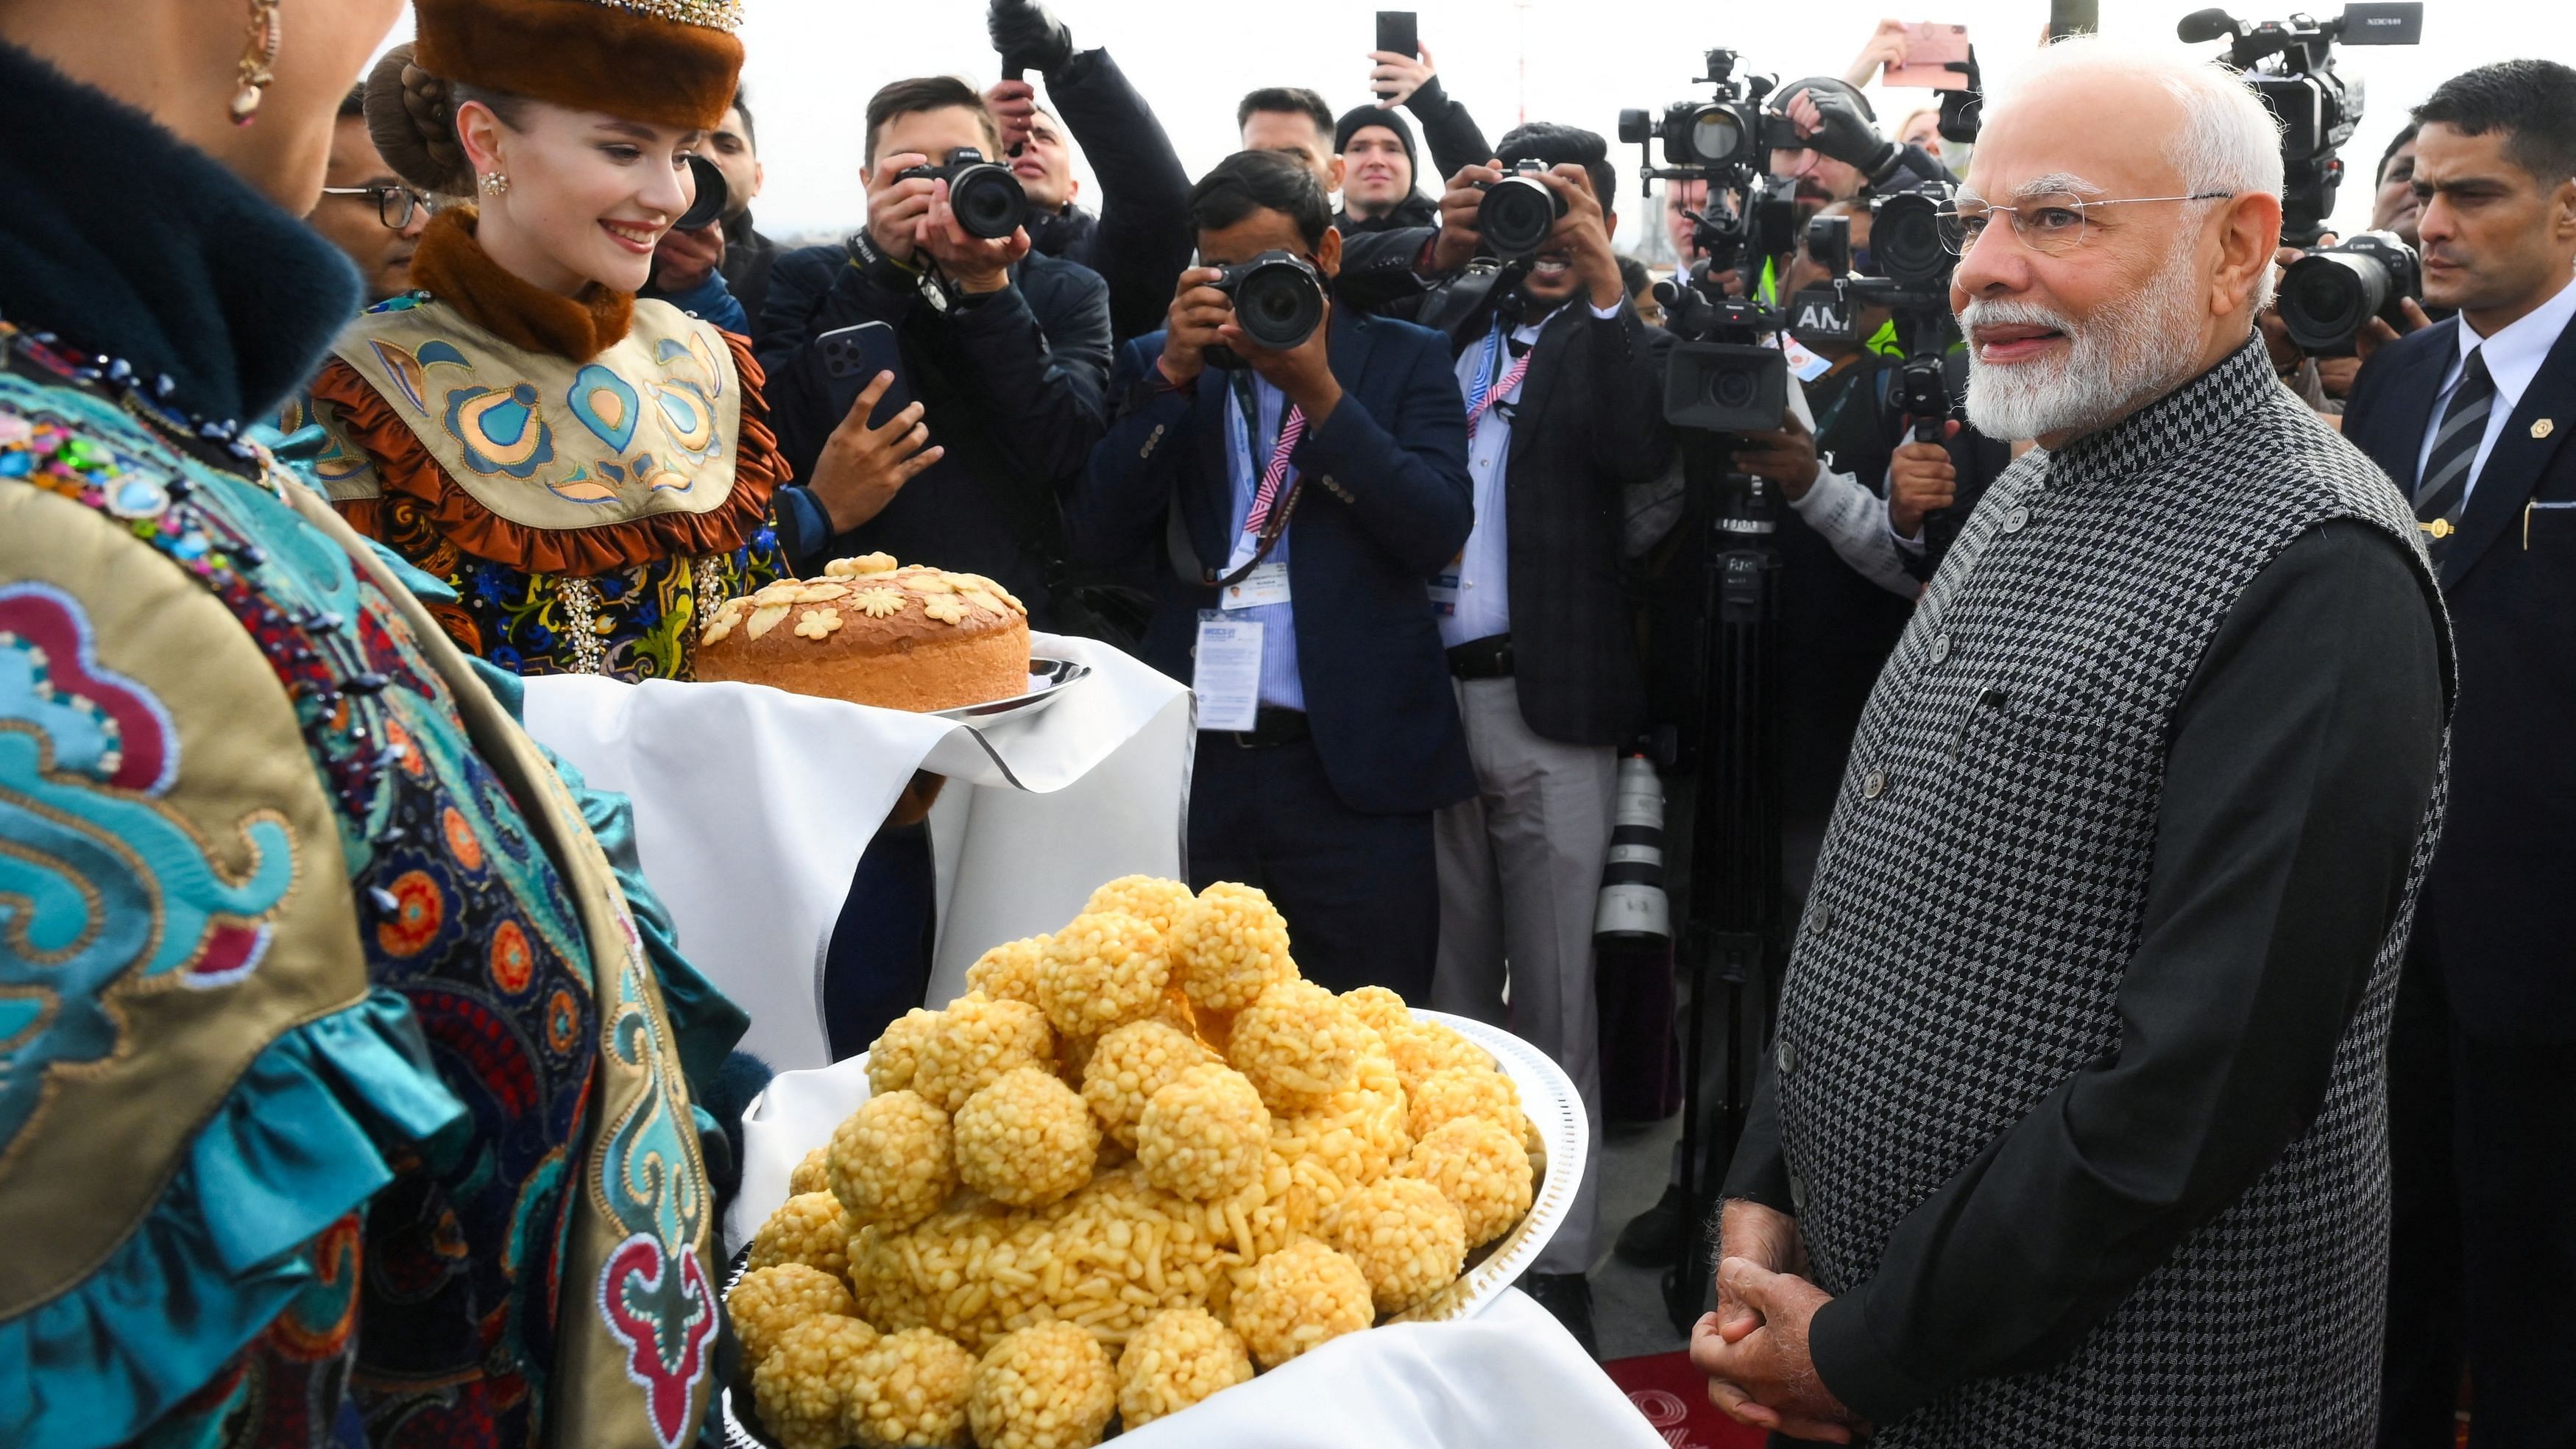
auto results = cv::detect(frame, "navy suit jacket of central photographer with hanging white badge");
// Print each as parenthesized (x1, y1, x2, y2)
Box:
(1066, 309, 1476, 813)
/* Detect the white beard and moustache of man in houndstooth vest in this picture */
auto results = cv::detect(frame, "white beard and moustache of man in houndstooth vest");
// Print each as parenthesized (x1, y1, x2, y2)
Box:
(1958, 237, 2203, 440)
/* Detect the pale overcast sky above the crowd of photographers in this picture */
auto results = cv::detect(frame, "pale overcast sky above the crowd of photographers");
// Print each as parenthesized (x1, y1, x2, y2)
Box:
(394, 0, 2576, 242)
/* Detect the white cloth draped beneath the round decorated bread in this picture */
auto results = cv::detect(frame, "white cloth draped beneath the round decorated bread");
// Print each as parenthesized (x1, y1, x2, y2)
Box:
(526, 633, 1195, 1065)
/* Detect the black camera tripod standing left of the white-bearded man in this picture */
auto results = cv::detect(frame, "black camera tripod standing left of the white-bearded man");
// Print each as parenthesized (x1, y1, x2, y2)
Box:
(1664, 430, 1780, 1331)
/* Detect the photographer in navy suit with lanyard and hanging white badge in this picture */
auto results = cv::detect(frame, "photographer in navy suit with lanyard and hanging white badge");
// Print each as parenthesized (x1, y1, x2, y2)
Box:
(1069, 152, 1476, 999)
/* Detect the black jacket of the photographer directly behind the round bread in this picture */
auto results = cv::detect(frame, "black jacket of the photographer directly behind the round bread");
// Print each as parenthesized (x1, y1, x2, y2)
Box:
(755, 247, 1111, 628)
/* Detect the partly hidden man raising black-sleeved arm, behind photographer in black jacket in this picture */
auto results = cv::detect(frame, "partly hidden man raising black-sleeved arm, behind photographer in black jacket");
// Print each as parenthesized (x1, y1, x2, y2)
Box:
(984, 0, 1190, 342)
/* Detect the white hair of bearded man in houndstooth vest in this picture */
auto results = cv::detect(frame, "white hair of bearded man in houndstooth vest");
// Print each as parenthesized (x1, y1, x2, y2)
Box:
(1981, 36, 2282, 311)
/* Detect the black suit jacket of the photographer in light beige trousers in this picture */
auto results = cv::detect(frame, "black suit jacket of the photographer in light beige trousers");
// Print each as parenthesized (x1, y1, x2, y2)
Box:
(1435, 283, 1672, 744)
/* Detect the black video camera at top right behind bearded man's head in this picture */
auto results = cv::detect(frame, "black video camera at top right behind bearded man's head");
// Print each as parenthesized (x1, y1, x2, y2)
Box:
(2174, 0, 2424, 247)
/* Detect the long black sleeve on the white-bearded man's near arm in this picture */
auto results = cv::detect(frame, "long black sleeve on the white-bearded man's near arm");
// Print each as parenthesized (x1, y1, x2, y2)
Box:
(1811, 522, 2442, 1423)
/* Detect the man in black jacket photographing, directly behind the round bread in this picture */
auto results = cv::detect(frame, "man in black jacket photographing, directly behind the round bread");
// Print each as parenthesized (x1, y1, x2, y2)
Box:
(760, 77, 1116, 638)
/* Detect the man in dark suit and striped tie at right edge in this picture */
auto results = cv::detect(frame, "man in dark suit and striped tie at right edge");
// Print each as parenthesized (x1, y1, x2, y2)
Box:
(2344, 59, 2576, 1444)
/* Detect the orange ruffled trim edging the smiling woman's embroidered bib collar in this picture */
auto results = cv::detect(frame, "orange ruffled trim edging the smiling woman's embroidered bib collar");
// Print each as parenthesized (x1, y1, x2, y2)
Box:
(312, 332, 793, 576)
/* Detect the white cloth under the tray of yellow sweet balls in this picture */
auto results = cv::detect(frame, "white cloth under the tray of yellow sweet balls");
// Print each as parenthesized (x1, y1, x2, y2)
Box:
(726, 1057, 1664, 1449)
